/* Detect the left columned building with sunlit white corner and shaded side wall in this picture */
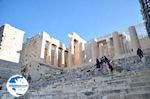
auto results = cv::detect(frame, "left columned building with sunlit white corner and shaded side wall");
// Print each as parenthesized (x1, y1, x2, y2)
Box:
(20, 32, 68, 67)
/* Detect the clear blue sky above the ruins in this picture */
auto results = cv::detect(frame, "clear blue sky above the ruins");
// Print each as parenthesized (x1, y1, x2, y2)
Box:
(0, 0, 142, 44)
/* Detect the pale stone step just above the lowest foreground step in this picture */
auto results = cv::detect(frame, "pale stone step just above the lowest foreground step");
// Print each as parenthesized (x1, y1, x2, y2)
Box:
(45, 84, 149, 92)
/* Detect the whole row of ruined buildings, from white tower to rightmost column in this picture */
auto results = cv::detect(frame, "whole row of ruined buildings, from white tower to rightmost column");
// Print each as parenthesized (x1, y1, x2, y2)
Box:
(0, 24, 149, 68)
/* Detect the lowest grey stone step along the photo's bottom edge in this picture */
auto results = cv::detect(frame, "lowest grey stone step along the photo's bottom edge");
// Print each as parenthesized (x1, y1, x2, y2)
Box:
(24, 90, 150, 99)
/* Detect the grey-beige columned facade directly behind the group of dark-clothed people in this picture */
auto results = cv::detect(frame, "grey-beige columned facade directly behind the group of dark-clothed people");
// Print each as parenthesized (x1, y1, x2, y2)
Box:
(86, 32, 127, 62)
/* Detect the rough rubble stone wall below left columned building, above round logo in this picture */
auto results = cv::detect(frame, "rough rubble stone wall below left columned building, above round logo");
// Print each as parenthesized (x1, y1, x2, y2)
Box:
(20, 61, 63, 82)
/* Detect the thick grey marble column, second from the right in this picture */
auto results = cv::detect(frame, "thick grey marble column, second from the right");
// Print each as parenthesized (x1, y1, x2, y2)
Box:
(112, 32, 122, 57)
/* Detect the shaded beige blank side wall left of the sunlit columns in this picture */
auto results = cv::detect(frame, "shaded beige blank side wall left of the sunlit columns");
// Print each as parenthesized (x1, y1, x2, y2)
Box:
(20, 35, 42, 66)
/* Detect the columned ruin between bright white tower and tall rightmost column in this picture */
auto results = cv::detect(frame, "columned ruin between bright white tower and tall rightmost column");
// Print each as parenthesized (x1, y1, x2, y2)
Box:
(20, 32, 129, 68)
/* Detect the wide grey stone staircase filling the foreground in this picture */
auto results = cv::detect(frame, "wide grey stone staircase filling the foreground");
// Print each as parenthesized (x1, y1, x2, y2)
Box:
(20, 62, 150, 99)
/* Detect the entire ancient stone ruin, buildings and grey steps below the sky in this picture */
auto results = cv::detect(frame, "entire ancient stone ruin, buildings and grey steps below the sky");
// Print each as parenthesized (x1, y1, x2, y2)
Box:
(0, 24, 150, 99)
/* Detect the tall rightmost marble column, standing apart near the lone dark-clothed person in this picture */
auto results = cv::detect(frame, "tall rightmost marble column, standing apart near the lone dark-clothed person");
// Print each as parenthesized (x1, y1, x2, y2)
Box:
(128, 26, 141, 52)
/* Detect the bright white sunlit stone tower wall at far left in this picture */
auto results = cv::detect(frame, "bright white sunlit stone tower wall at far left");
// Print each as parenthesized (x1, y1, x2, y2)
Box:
(0, 24, 24, 63)
